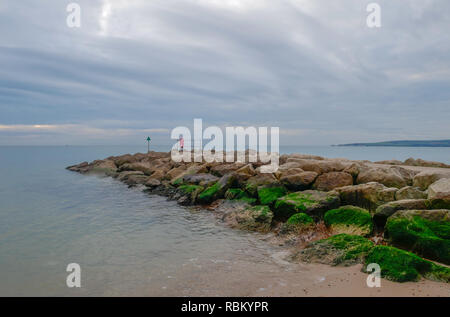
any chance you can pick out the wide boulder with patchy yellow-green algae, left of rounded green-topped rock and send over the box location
[274,190,340,219]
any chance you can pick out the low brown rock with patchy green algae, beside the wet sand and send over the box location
[298,233,374,266]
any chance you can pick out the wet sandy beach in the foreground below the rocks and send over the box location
[139,239,450,297]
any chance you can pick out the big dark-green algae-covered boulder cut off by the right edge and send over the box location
[385,209,450,264]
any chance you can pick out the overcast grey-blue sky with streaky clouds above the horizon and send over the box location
[0,0,450,145]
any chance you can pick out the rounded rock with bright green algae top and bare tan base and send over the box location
[323,206,373,236]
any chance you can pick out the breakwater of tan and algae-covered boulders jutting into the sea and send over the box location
[67,151,450,296]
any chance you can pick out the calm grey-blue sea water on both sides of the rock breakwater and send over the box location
[0,146,450,296]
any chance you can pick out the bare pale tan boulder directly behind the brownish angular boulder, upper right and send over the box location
[356,166,412,188]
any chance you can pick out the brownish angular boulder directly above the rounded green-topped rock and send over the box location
[335,182,398,211]
